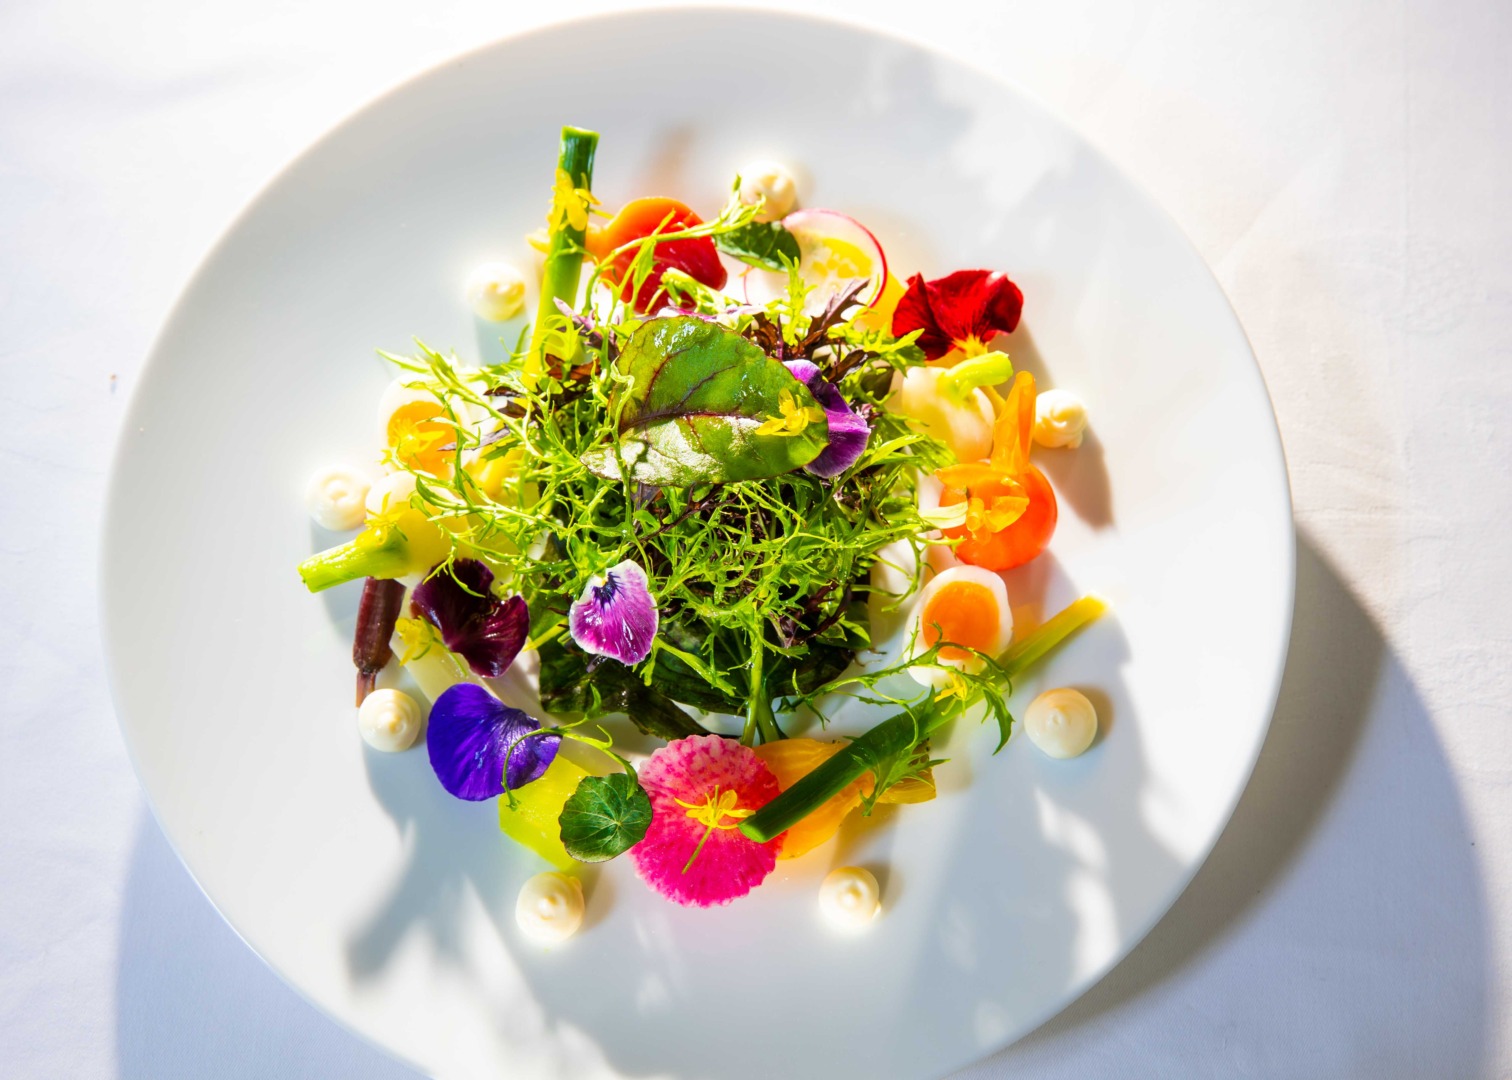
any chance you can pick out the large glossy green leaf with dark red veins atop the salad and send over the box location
[584,316,830,487]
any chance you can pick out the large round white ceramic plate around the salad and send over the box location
[104,12,1293,1077]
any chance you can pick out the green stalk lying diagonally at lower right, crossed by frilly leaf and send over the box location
[741,596,1107,844]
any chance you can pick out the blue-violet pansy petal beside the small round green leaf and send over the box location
[425,682,562,802]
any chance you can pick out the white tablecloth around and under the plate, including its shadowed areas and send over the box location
[0,0,1512,1080]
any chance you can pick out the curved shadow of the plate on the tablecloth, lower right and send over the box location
[985,534,1494,1080]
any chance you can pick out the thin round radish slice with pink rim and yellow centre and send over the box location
[744,210,888,315]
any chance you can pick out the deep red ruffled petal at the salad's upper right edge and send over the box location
[892,271,1024,360]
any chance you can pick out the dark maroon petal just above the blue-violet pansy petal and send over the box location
[410,558,531,679]
